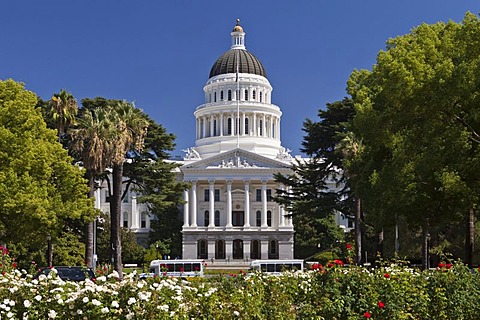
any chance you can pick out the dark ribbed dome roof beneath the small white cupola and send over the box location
[209,49,267,78]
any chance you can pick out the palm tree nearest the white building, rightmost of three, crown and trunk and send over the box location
[109,101,148,277]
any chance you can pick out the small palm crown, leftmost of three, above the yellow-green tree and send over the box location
[49,89,78,141]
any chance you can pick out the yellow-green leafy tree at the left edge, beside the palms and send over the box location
[0,80,94,262]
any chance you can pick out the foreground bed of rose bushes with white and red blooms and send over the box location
[0,254,480,320]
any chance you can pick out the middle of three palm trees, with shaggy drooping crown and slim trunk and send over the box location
[71,108,114,267]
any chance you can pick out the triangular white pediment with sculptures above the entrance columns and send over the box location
[181,149,290,170]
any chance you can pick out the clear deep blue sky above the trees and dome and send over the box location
[0,0,480,155]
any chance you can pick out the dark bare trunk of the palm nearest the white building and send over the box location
[110,163,123,278]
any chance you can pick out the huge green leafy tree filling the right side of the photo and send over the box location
[348,13,480,267]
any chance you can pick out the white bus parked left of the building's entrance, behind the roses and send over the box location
[149,259,205,277]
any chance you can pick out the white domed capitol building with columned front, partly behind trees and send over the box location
[97,20,347,261]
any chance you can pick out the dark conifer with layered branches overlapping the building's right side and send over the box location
[275,99,354,257]
